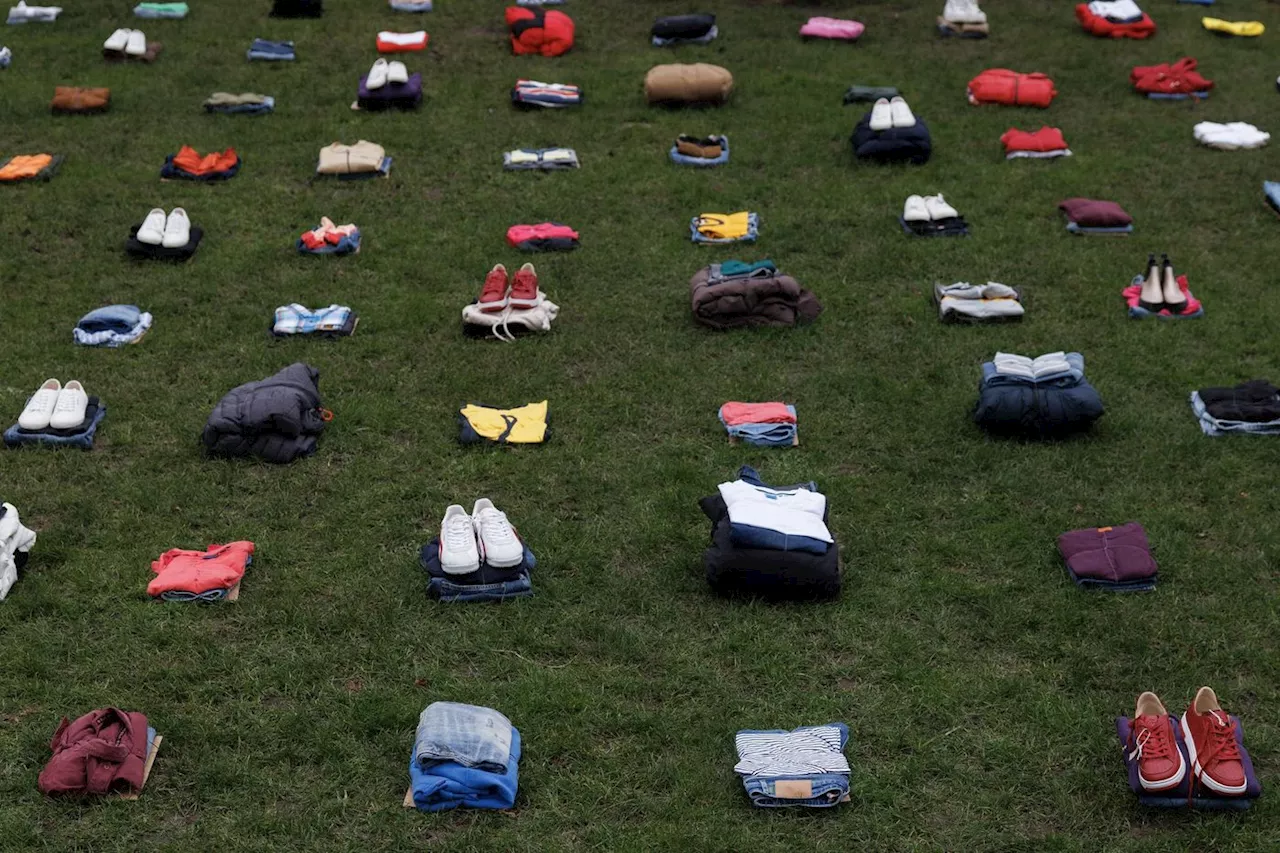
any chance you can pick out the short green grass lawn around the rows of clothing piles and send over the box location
[0,0,1280,852]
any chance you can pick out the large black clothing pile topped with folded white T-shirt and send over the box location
[698,465,840,601]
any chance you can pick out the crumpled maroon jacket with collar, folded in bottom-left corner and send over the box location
[36,708,147,795]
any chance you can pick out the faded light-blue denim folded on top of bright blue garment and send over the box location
[404,702,521,812]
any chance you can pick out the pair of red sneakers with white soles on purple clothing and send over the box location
[1132,686,1248,797]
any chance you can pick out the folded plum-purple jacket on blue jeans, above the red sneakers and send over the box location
[1057,521,1158,592]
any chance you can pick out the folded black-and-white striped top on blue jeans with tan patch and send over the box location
[733,722,850,808]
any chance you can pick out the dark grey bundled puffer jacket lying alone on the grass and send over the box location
[204,362,325,464]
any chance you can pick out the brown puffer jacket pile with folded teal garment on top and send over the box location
[689,260,822,329]
